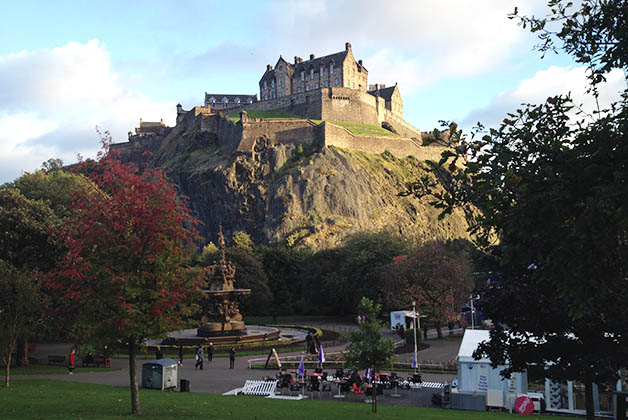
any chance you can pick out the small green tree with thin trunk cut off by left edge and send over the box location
[0,260,42,387]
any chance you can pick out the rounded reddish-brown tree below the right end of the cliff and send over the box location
[384,241,472,338]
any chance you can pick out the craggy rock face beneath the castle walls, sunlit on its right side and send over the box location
[113,127,468,249]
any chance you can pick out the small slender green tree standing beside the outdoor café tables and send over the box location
[347,297,393,413]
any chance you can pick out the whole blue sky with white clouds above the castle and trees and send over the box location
[0,0,625,184]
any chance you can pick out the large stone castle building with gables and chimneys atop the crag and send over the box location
[259,42,368,101]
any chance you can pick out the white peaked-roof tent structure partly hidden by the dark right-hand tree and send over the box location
[456,329,528,409]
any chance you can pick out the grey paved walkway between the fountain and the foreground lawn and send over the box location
[14,322,459,406]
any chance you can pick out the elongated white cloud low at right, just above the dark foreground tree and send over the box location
[462,66,626,128]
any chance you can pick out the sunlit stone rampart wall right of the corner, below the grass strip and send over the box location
[322,122,445,161]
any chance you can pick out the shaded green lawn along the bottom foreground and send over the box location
[0,379,567,420]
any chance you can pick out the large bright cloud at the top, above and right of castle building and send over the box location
[260,0,544,93]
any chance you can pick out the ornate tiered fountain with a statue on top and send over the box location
[196,228,251,337]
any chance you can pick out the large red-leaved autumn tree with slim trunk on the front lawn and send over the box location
[43,150,201,413]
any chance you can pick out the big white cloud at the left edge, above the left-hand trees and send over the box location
[0,40,176,182]
